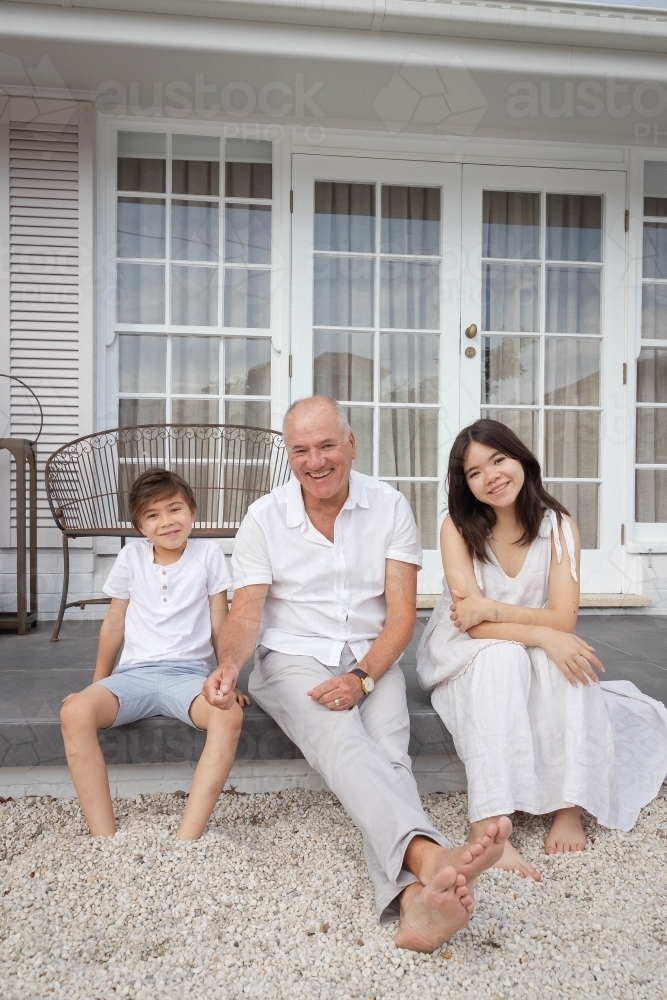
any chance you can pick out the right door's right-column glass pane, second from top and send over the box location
[546,267,602,333]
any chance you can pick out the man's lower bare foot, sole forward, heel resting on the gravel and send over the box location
[394,865,474,952]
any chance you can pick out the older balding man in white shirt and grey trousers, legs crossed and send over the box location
[204,396,511,951]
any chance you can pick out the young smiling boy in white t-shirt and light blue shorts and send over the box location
[60,469,250,840]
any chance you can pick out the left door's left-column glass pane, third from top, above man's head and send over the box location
[313,330,374,402]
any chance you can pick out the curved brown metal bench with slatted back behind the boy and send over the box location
[44,424,290,642]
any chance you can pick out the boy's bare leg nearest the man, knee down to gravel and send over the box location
[178,695,243,840]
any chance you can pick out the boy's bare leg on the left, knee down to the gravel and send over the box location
[60,684,118,837]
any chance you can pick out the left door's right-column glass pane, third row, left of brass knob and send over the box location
[380,333,440,403]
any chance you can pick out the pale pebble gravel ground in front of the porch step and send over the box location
[0,786,667,1000]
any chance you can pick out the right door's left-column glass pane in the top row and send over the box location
[482,191,540,260]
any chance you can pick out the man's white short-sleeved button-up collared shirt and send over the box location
[232,472,422,666]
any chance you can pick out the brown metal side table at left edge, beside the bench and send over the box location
[0,438,37,635]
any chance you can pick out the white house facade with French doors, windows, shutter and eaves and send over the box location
[0,0,667,617]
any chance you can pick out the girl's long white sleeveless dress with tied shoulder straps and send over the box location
[417,510,667,830]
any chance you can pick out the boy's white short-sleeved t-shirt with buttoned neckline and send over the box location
[103,538,232,666]
